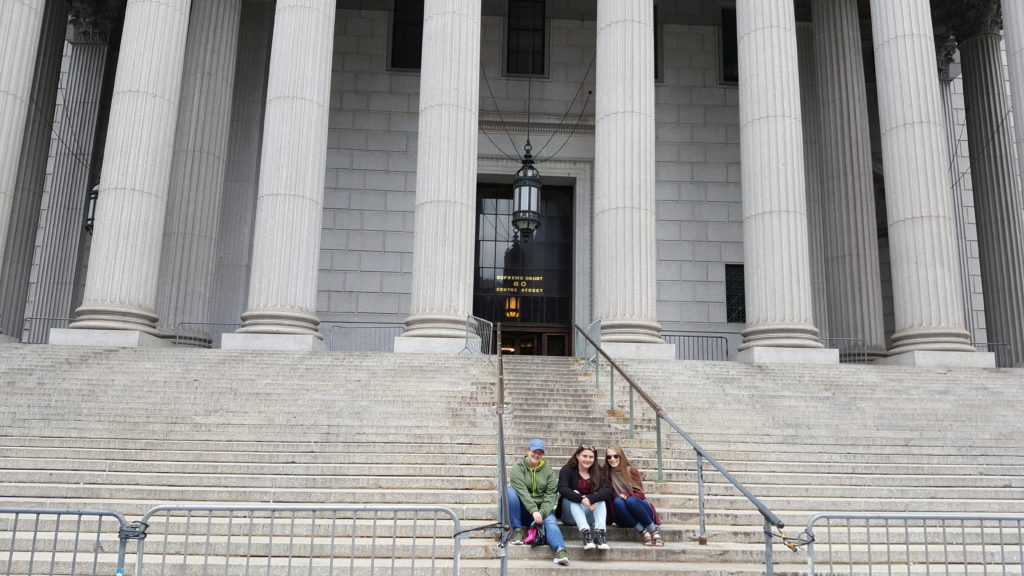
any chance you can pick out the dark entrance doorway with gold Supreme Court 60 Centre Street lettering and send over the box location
[473,183,573,356]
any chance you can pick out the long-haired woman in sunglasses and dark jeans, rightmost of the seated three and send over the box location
[604,445,665,546]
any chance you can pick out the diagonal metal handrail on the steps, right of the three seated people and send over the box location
[573,324,785,576]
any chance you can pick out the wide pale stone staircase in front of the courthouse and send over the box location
[0,344,1024,575]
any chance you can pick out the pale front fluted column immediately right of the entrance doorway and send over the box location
[594,0,671,357]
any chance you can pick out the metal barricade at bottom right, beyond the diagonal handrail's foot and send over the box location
[804,513,1024,576]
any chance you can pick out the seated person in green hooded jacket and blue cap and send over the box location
[509,438,569,566]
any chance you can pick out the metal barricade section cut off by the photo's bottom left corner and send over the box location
[0,508,133,576]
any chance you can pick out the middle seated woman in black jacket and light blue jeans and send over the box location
[558,444,611,550]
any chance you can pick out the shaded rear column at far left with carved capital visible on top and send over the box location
[29,13,110,341]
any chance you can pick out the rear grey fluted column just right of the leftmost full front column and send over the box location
[157,0,242,345]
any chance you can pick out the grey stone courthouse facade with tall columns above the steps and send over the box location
[0,0,1024,366]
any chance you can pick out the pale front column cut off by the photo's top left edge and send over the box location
[0,0,46,313]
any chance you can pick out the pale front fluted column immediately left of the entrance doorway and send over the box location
[394,0,480,354]
